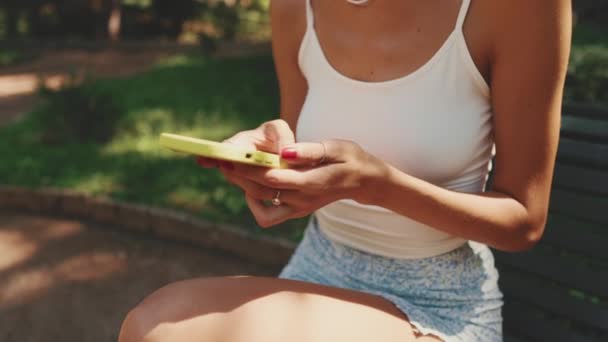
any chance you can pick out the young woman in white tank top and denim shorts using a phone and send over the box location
[120,0,571,342]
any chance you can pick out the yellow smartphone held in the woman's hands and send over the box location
[160,133,287,169]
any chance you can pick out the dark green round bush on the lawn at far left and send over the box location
[35,83,123,144]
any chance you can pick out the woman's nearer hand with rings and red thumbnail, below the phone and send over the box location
[220,140,388,227]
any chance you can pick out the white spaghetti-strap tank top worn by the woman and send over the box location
[296,0,494,259]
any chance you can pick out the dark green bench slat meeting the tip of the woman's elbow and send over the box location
[540,213,608,260]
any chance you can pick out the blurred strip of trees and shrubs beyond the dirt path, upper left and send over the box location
[0,0,269,42]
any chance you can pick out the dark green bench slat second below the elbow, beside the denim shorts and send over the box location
[500,272,608,334]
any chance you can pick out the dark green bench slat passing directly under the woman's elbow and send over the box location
[494,248,608,298]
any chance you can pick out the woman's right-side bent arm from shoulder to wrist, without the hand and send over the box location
[364,0,572,251]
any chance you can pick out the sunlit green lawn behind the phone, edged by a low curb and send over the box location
[0,56,302,239]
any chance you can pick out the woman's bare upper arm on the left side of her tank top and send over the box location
[270,0,308,132]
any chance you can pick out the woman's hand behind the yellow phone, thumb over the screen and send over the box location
[197,119,295,170]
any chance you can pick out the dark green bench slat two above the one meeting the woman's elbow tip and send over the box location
[553,163,608,195]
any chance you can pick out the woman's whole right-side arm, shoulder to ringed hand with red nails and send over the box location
[217,0,571,251]
